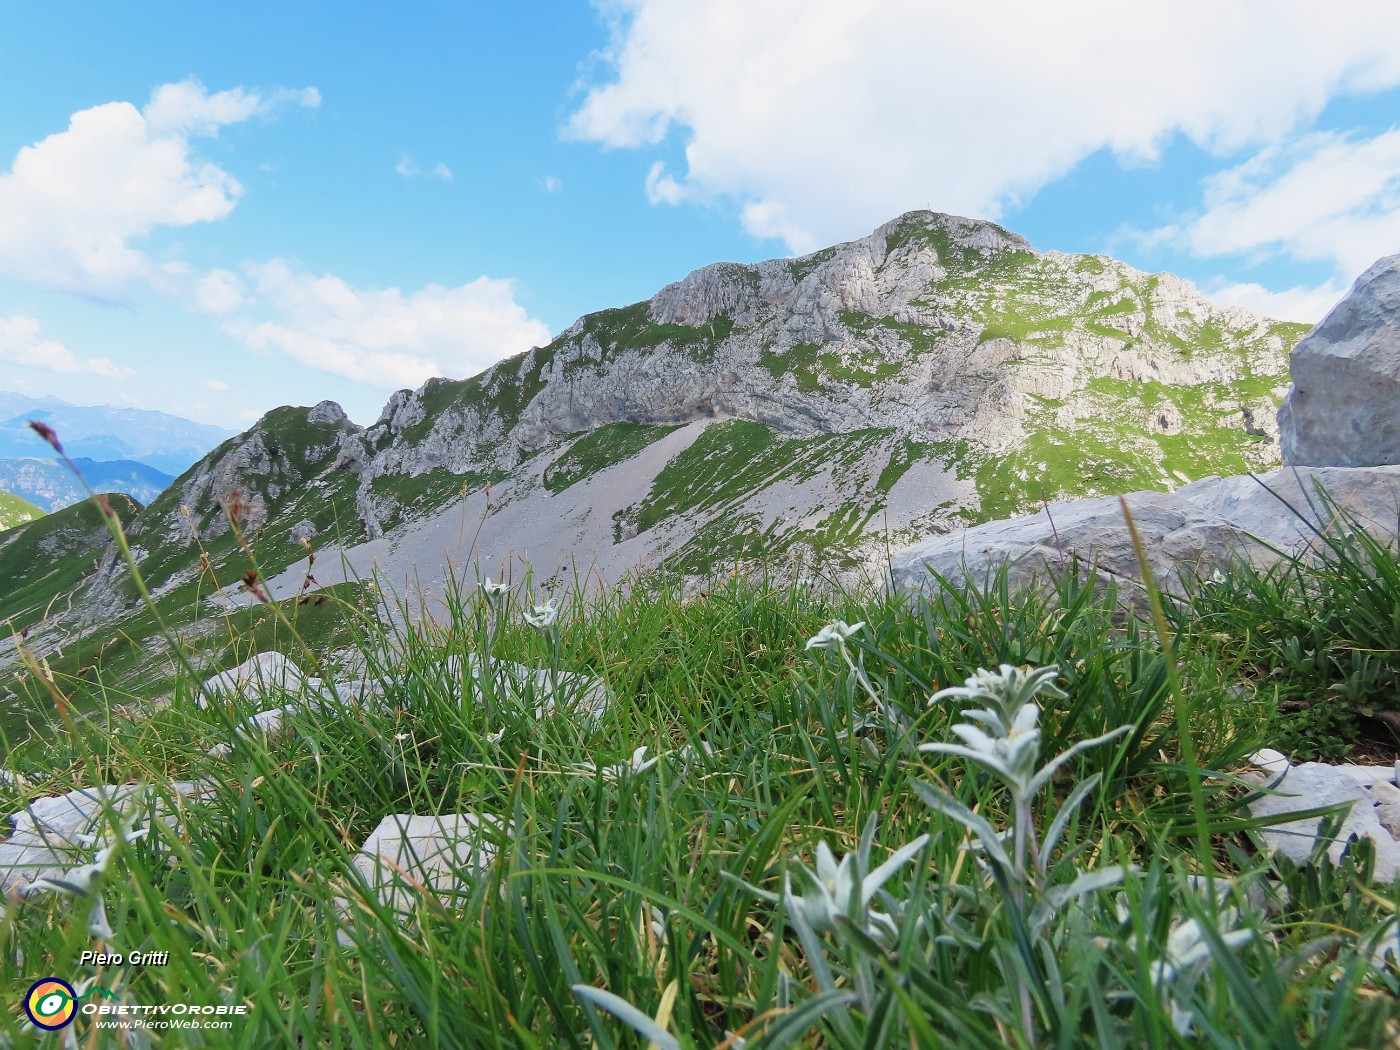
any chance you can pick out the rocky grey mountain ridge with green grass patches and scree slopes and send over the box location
[0,211,1305,700]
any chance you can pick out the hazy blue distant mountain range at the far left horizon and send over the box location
[0,391,234,477]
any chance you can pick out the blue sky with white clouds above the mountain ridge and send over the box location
[0,0,1400,427]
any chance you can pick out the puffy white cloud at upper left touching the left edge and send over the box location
[0,80,319,300]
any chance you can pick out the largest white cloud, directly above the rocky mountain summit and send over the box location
[567,0,1400,249]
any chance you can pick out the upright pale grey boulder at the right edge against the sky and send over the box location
[1278,255,1400,466]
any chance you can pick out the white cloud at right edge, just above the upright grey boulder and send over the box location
[1149,130,1400,277]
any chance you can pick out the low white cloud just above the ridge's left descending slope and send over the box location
[225,259,549,389]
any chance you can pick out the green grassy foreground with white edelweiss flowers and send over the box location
[0,518,1400,1050]
